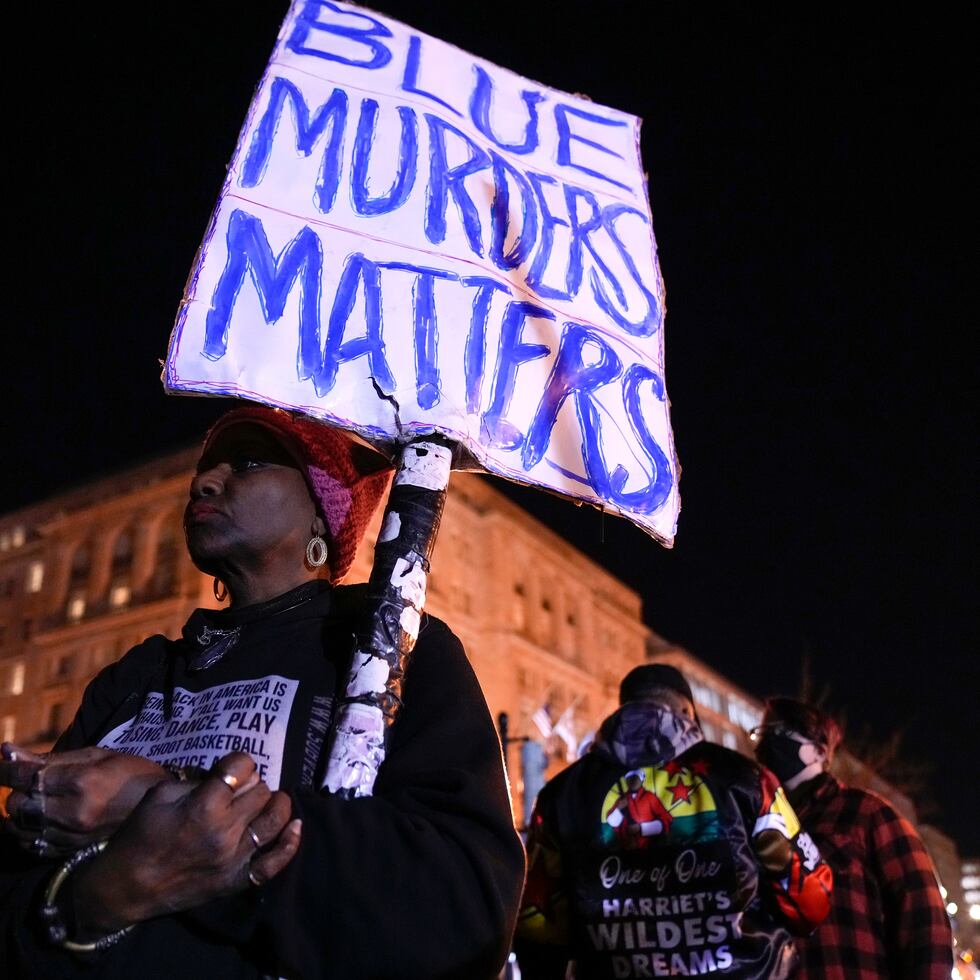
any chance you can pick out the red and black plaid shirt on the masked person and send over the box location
[790,775,953,980]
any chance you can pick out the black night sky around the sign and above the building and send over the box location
[0,0,980,855]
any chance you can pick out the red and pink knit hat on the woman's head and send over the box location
[201,405,392,582]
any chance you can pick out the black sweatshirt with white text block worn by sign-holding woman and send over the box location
[0,588,524,980]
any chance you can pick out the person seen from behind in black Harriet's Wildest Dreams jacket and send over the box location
[515,664,832,980]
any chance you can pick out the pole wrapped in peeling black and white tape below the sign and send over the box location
[323,436,453,798]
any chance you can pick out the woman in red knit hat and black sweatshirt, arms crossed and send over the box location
[0,407,524,980]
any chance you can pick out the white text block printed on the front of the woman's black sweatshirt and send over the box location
[99,674,299,789]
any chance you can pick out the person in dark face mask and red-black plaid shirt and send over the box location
[753,698,953,980]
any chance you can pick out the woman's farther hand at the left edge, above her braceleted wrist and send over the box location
[0,743,173,857]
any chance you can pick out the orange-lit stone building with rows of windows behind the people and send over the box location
[0,447,964,896]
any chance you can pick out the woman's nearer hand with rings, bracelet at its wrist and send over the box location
[73,752,300,936]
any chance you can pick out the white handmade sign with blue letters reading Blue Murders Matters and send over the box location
[164,0,679,545]
